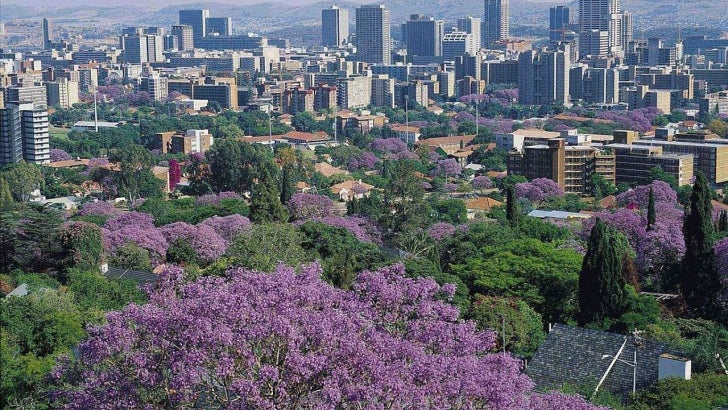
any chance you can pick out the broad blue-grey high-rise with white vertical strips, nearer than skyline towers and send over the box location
[518,45,571,105]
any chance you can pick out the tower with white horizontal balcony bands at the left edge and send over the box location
[0,101,50,166]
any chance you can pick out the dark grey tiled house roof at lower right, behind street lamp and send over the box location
[526,324,670,397]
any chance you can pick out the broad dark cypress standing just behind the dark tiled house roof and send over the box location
[577,219,627,326]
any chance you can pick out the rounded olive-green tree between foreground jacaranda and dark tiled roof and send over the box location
[467,295,546,357]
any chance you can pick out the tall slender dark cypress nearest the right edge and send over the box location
[680,172,720,317]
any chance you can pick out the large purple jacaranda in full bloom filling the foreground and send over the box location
[49,265,594,410]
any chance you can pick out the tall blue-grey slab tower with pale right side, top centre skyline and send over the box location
[356,5,392,65]
